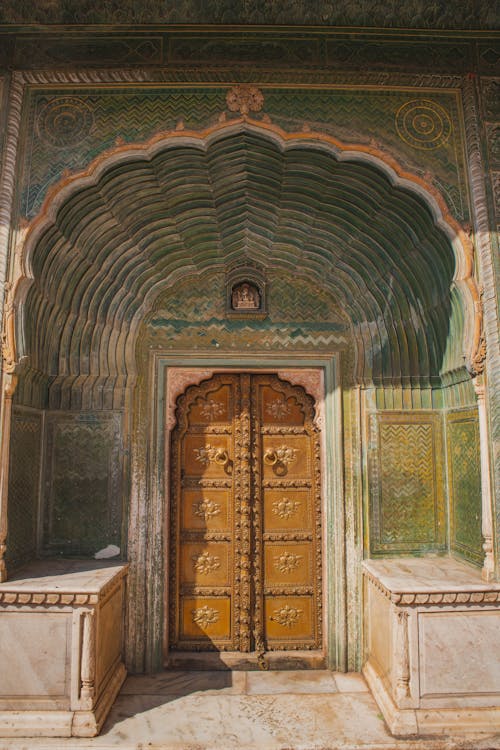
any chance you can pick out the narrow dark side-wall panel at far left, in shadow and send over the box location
[7,409,42,568]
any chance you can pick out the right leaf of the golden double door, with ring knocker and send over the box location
[252,375,321,651]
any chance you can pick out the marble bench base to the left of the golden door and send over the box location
[0,560,127,737]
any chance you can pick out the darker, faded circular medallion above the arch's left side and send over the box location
[37,96,94,148]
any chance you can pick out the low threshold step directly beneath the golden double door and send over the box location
[165,651,326,671]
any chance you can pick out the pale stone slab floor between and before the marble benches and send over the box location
[0,671,500,750]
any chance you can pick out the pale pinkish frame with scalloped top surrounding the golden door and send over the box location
[148,352,347,669]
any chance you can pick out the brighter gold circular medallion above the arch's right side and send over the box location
[396,99,452,150]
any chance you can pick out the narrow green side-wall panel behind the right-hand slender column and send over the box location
[446,409,483,565]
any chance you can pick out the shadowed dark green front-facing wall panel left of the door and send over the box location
[44,412,123,556]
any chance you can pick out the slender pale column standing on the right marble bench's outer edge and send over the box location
[473,376,495,581]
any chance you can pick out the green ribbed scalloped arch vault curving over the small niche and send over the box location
[16,122,473,408]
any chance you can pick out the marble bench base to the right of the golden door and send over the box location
[363,558,500,736]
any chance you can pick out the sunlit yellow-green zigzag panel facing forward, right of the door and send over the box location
[370,411,446,555]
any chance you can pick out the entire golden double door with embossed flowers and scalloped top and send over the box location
[169,373,322,666]
